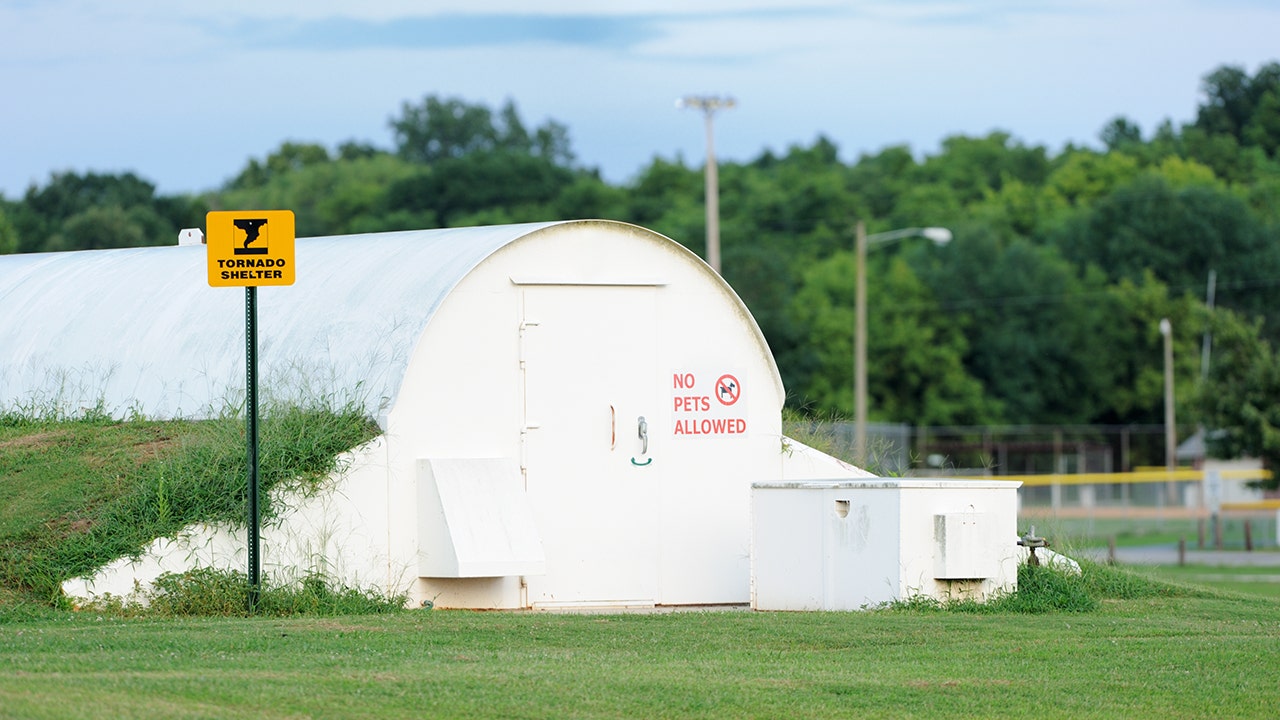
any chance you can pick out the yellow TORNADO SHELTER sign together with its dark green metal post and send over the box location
[205,210,294,612]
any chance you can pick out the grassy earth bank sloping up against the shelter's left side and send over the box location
[0,406,376,605]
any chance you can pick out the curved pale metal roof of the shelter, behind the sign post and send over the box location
[0,223,562,416]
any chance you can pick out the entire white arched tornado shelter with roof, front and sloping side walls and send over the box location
[0,220,864,607]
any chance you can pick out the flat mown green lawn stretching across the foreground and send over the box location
[0,597,1280,719]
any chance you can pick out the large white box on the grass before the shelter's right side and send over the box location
[751,478,1021,610]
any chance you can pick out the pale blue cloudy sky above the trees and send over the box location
[0,0,1280,200]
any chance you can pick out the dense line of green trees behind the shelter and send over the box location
[0,63,1280,476]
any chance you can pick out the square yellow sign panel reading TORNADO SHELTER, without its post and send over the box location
[205,210,294,287]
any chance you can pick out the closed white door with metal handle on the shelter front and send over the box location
[521,284,667,606]
